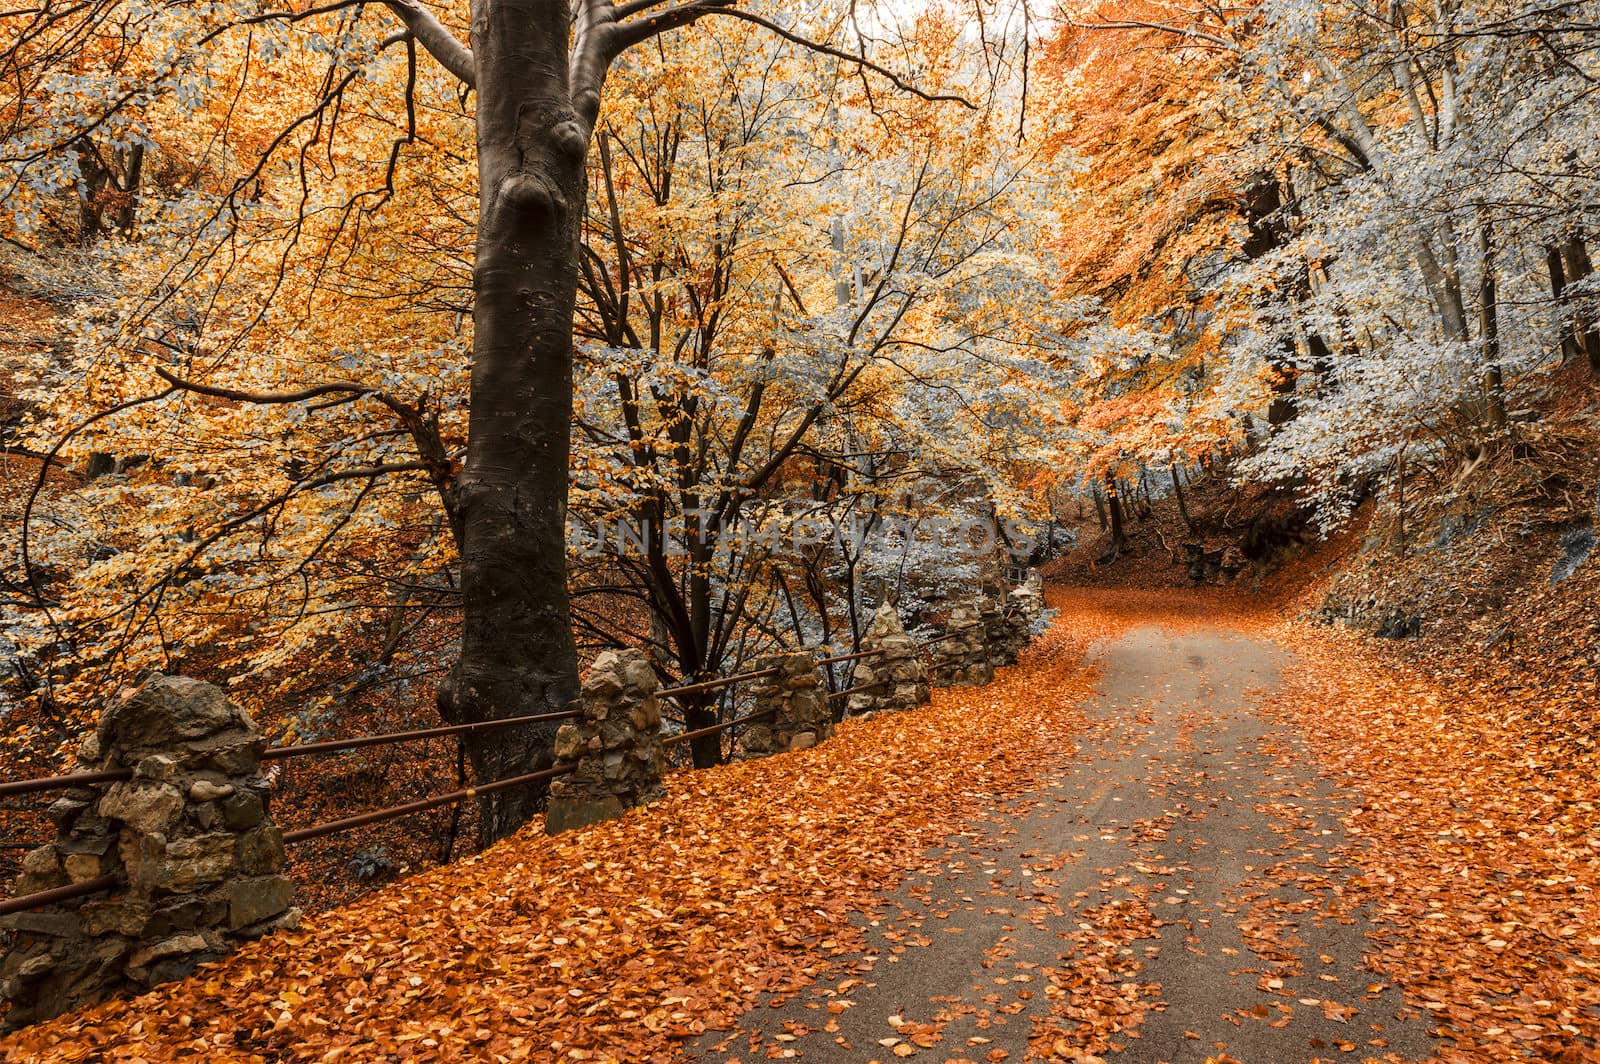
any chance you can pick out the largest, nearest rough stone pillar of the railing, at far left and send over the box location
[0,677,299,1027]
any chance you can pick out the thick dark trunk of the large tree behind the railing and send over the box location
[438,0,587,842]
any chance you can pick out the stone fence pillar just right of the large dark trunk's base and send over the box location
[544,650,666,835]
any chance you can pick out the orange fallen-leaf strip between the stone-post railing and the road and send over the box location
[0,624,1088,1062]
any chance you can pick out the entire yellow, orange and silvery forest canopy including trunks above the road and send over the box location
[0,0,1600,832]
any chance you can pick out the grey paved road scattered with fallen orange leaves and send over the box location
[690,627,1432,1064]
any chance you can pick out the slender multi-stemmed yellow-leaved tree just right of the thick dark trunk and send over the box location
[574,16,1075,763]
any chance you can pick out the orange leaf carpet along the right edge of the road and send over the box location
[1267,626,1600,1062]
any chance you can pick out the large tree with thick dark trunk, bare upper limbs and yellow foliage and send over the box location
[3,0,1049,835]
